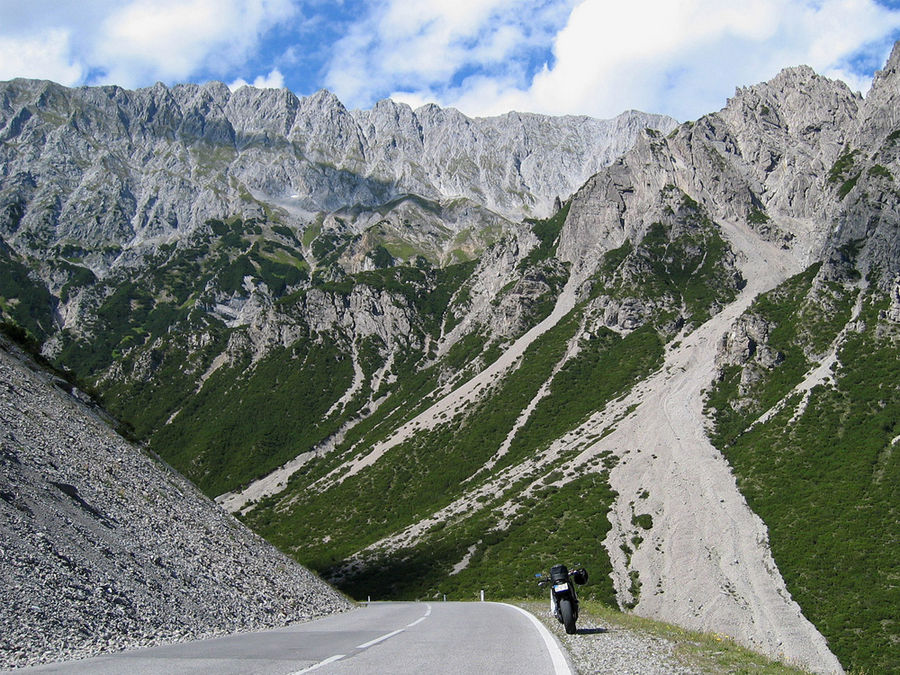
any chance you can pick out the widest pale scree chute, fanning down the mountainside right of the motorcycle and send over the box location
[575,223,842,673]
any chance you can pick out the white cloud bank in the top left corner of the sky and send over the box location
[0,0,297,87]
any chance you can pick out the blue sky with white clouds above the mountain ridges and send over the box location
[0,0,900,121]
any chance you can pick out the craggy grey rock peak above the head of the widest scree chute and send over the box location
[559,42,900,289]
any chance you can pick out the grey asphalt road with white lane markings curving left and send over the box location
[16,602,571,675]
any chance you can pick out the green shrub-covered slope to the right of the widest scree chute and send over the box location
[714,288,900,672]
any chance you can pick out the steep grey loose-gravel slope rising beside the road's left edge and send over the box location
[0,341,350,668]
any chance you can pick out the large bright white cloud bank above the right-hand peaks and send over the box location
[327,0,900,119]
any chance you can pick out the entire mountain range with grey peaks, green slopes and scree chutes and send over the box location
[0,46,900,672]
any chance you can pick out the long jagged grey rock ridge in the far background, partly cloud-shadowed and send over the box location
[0,80,675,270]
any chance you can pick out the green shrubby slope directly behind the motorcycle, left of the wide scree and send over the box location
[320,472,615,602]
